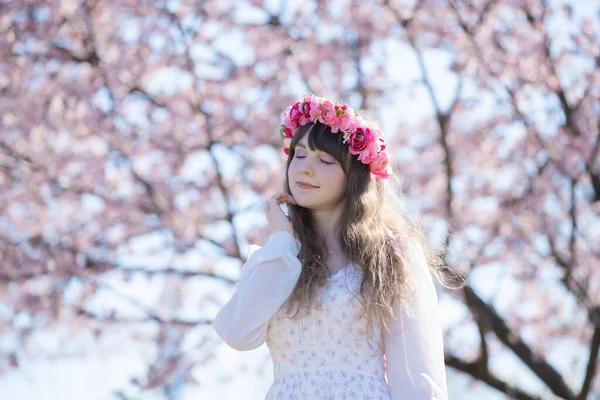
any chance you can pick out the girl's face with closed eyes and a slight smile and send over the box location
[288,134,346,210]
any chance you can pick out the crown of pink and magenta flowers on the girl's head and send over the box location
[280,95,392,179]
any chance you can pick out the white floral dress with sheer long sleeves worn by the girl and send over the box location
[215,231,447,400]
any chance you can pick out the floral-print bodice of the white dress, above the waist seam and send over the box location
[266,264,386,398]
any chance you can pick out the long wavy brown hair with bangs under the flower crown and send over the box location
[284,122,460,353]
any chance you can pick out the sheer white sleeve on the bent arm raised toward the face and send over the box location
[214,230,302,351]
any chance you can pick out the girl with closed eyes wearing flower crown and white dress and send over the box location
[215,95,447,400]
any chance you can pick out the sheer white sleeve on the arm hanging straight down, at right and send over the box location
[385,244,448,400]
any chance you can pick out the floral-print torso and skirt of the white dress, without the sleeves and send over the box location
[265,264,390,400]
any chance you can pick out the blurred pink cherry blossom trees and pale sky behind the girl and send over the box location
[0,0,600,400]
